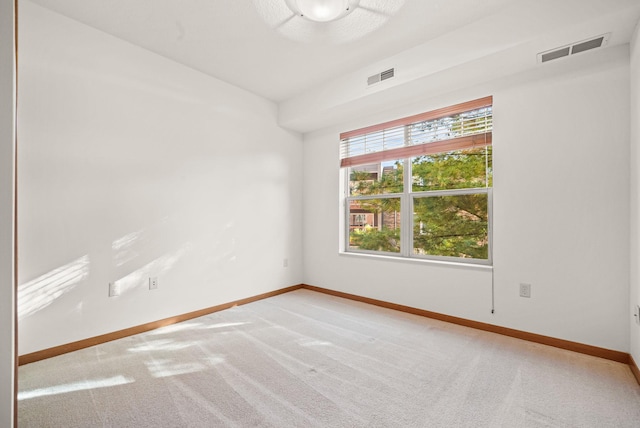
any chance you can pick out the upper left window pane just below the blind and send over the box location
[349,160,403,196]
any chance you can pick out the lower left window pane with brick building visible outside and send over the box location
[349,198,400,253]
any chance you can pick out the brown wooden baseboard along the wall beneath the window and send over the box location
[302,284,640,364]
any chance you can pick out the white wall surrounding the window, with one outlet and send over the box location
[303,45,629,352]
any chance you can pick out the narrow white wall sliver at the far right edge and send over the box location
[629,23,640,364]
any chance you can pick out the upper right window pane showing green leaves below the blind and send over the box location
[411,146,492,192]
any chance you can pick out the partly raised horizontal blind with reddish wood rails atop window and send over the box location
[340,96,493,167]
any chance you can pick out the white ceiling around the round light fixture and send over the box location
[21,0,640,131]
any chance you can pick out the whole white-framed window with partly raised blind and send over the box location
[340,97,493,264]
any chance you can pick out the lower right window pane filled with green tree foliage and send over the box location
[413,193,489,259]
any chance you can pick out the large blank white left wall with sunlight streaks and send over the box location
[18,2,302,354]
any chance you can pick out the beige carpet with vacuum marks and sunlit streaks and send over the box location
[19,290,640,428]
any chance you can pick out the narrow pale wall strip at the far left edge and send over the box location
[0,0,15,427]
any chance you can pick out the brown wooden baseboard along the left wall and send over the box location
[18,285,302,365]
